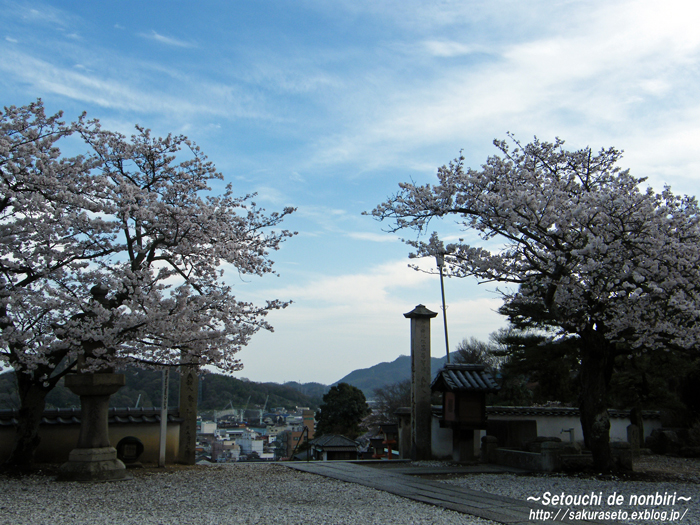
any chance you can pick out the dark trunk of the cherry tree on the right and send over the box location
[579,329,614,472]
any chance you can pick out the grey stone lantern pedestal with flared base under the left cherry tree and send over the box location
[58,373,130,481]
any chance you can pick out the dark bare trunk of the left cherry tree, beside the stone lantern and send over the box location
[5,372,50,471]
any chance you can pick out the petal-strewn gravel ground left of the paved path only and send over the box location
[0,463,493,525]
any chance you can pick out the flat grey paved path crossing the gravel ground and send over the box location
[285,461,600,525]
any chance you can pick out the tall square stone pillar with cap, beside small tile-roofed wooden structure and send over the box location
[403,304,437,460]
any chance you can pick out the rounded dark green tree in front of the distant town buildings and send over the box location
[316,383,370,439]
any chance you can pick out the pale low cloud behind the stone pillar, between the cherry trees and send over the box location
[234,260,505,384]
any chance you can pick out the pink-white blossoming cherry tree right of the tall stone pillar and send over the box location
[372,137,700,471]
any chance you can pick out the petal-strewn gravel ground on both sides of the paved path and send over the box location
[0,457,700,525]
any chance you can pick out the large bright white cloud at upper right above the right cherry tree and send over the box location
[313,2,700,184]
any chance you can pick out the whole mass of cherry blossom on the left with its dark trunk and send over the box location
[0,101,293,465]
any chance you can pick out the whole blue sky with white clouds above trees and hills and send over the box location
[0,0,700,383]
